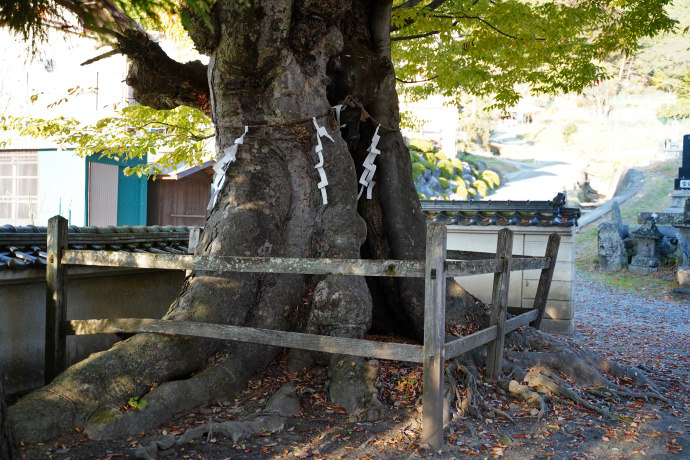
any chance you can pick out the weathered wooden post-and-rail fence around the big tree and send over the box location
[45,216,560,448]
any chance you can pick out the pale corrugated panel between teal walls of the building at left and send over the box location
[88,161,120,226]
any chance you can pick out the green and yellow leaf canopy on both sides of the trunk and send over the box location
[0,0,678,174]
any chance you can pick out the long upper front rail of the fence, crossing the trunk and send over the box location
[62,249,425,278]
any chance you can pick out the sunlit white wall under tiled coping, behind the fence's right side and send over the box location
[448,225,575,335]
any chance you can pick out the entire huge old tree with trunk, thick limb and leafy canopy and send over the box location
[0,0,674,446]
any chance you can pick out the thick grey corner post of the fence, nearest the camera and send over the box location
[422,223,447,449]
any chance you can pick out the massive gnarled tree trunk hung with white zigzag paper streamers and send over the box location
[5,0,481,441]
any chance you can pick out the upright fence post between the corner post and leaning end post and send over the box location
[486,228,513,379]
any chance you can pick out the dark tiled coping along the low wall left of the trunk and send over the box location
[0,225,191,270]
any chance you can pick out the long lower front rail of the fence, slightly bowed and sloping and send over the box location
[62,318,422,363]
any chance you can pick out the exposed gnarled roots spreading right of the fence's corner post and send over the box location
[446,328,670,428]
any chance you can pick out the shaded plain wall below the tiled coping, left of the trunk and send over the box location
[0,267,184,395]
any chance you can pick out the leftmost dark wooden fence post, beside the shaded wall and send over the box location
[44,216,67,384]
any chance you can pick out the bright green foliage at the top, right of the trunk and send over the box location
[392,0,676,107]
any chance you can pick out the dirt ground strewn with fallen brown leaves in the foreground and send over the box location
[12,328,690,460]
